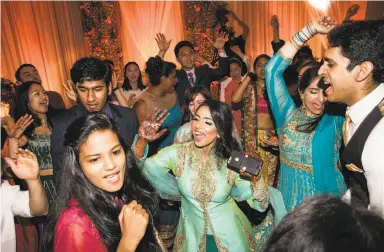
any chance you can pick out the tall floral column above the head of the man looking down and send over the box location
[79,1,123,75]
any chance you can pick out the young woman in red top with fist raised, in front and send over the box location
[44,113,165,252]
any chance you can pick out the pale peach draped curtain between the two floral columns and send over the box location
[119,1,184,70]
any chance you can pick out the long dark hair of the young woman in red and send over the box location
[44,113,158,251]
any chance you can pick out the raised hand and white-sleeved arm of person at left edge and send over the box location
[0,149,48,252]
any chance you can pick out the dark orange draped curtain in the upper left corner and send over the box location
[1,1,87,105]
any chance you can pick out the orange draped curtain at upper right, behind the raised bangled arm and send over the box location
[228,1,367,59]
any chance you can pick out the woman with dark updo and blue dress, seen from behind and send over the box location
[134,56,183,249]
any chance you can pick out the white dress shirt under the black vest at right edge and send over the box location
[344,83,384,218]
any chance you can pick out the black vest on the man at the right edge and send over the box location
[341,100,384,207]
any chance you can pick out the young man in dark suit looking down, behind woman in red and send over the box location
[51,57,145,181]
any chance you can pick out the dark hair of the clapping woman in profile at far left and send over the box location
[13,81,58,139]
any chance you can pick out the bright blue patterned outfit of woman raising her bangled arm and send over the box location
[265,53,346,211]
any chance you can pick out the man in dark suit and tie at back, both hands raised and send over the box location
[157,33,229,106]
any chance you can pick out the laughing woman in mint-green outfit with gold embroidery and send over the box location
[136,100,285,252]
